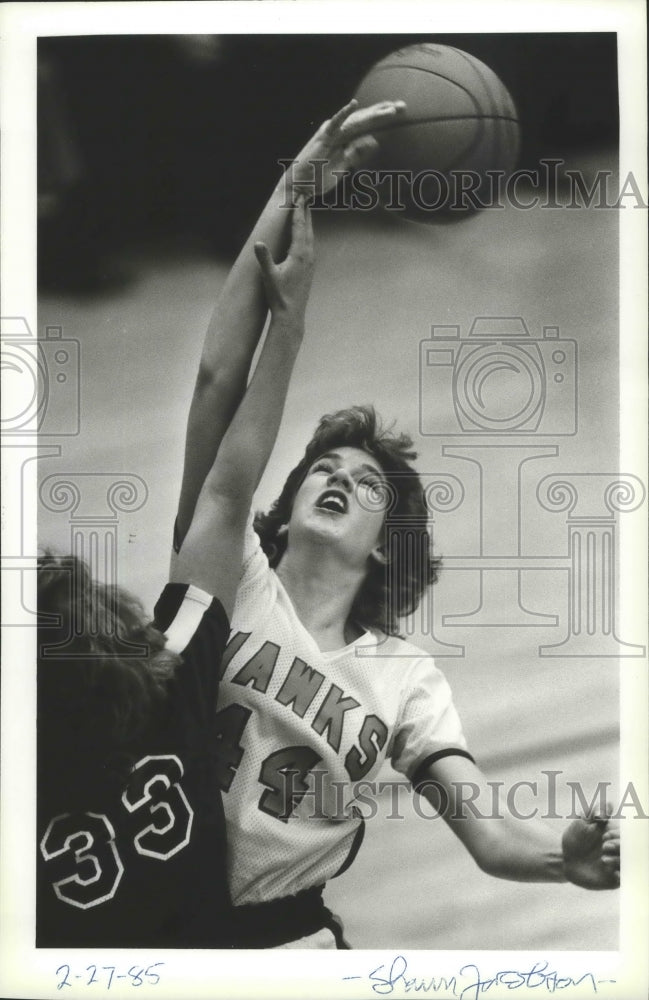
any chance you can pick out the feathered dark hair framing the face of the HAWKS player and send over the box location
[254,406,440,635]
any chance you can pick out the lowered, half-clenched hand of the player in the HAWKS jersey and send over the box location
[561,813,620,889]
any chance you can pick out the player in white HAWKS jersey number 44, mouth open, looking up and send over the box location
[177,103,619,947]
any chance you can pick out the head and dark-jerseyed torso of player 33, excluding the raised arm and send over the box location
[37,556,229,947]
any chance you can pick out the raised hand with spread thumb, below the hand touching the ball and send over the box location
[255,194,314,327]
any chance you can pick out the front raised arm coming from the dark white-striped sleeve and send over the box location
[170,196,313,614]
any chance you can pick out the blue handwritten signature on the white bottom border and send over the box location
[344,955,615,1000]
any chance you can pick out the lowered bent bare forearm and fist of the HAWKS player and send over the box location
[422,756,619,889]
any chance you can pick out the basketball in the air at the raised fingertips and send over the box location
[355,43,520,222]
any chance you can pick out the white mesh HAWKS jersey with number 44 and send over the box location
[217,524,465,905]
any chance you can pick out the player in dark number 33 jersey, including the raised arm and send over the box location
[37,197,313,948]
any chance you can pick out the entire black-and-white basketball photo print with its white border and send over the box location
[2,4,649,998]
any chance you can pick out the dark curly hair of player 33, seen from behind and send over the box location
[37,552,180,769]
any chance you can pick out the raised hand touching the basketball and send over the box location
[289,100,405,197]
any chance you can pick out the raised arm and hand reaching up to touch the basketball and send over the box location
[177,101,403,541]
